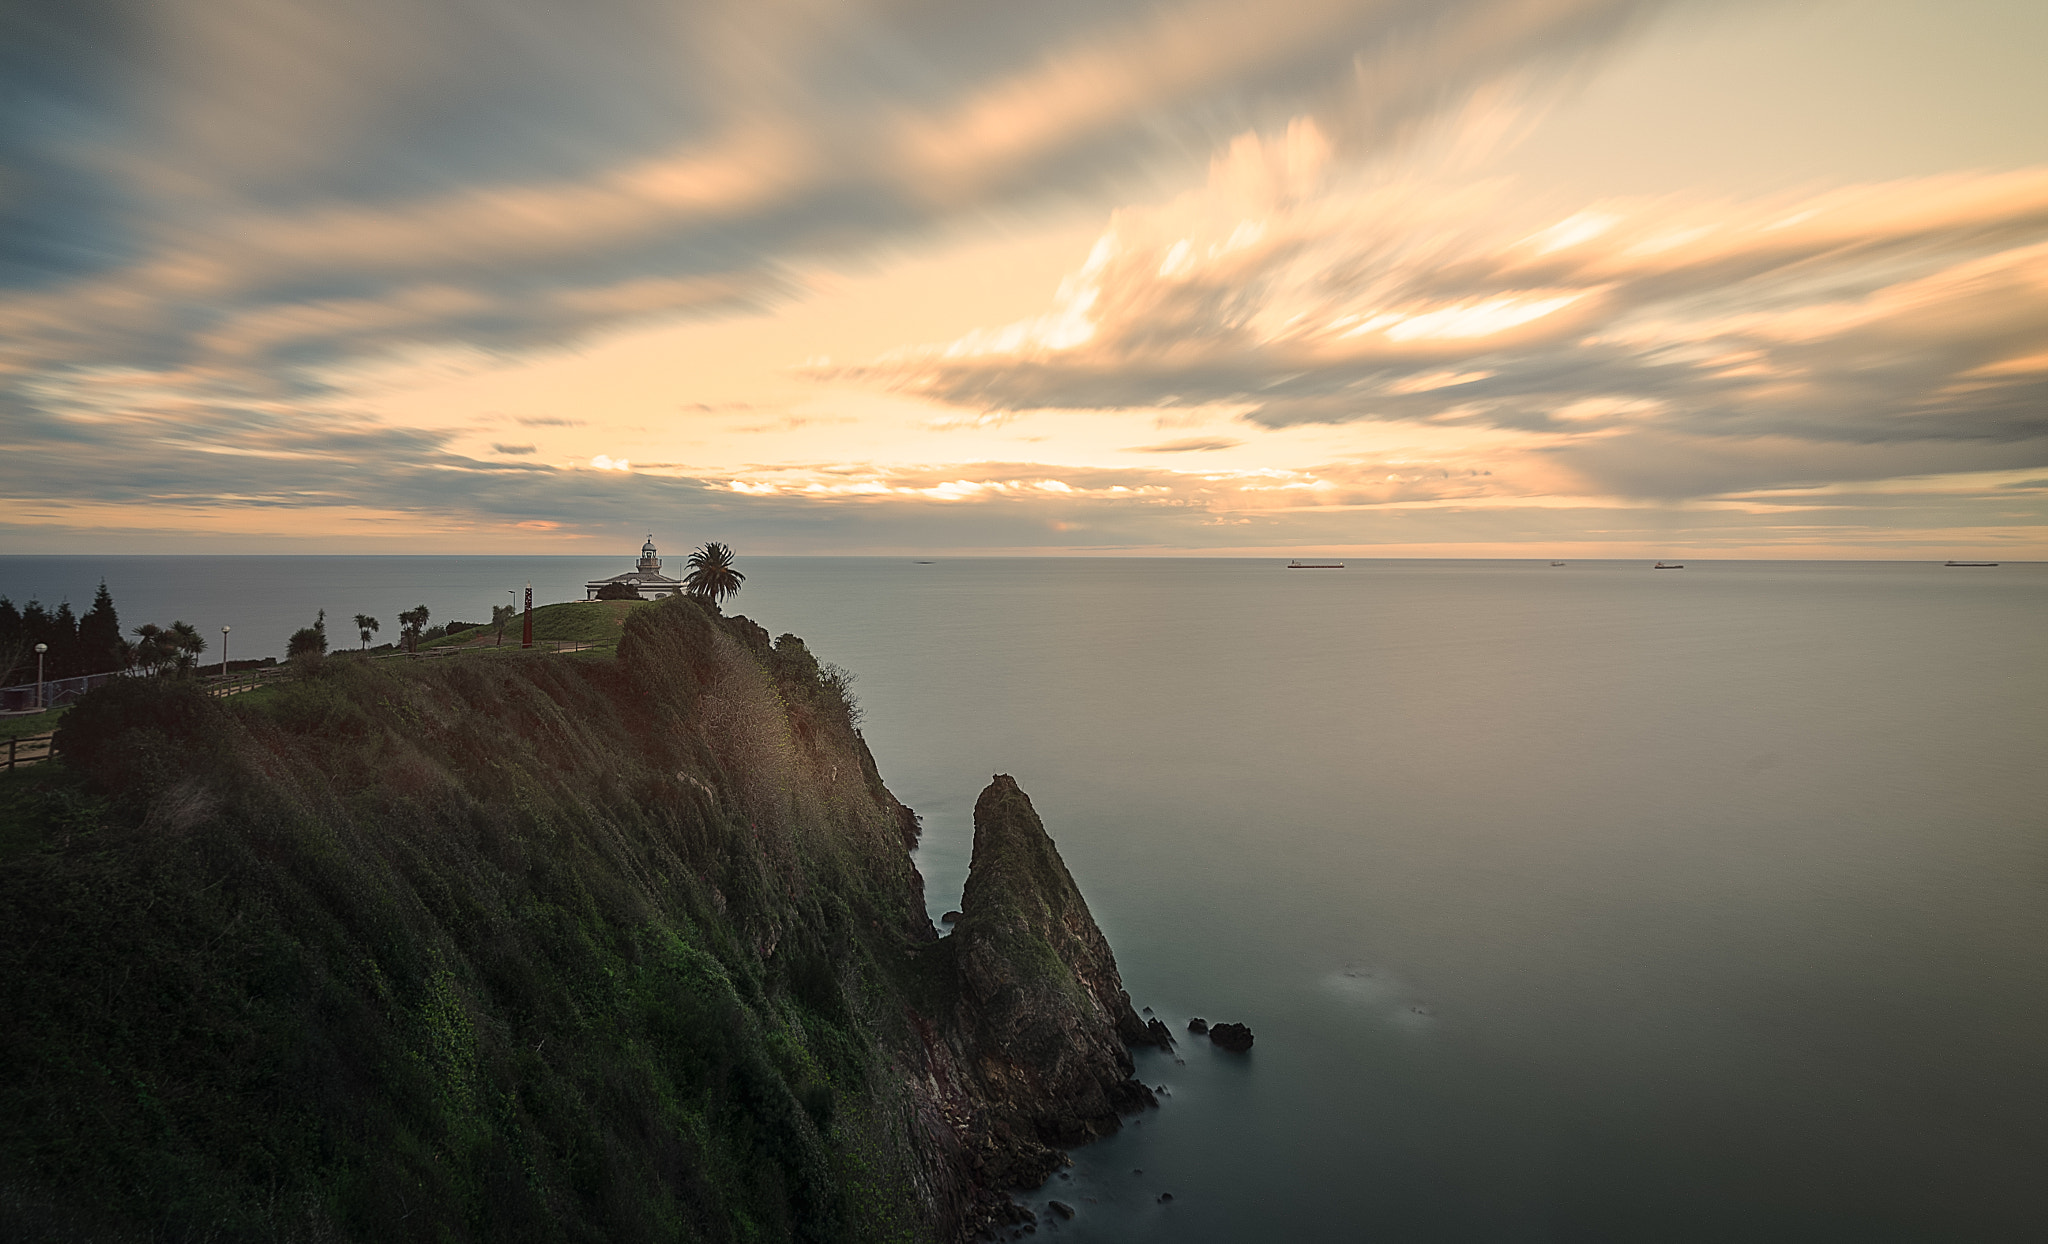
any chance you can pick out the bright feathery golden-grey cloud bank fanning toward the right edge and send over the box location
[836,121,2048,496]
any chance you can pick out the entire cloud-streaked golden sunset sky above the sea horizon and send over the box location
[0,0,2048,559]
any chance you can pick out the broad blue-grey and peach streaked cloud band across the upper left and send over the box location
[0,0,1657,397]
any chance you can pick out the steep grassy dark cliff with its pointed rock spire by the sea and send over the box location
[0,600,1149,1244]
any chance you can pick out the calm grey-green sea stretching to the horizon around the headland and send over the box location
[0,557,2048,1242]
